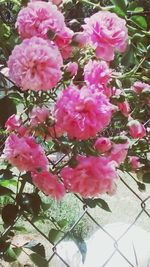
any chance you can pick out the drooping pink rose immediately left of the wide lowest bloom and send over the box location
[31,171,65,200]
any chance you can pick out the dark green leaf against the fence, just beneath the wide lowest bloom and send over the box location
[84,198,111,212]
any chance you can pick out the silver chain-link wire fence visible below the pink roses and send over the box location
[0,120,150,267]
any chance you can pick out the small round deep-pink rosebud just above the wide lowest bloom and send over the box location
[94,137,112,153]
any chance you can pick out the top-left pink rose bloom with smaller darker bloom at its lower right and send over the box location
[16,1,73,59]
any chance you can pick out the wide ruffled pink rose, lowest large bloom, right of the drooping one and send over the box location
[61,156,117,198]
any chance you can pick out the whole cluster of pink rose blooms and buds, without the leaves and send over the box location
[4,0,150,203]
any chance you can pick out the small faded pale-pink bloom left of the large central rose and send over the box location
[29,106,50,126]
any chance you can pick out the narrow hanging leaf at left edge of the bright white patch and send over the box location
[71,232,87,263]
